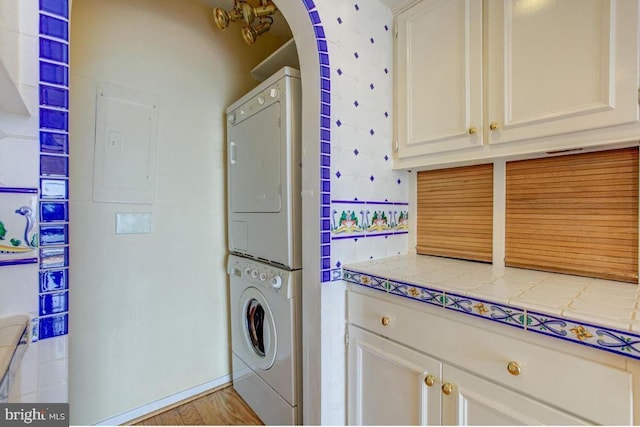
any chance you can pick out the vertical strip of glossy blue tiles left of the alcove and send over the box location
[38,0,69,341]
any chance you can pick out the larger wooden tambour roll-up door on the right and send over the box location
[505,148,638,283]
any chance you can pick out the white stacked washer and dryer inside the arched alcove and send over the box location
[227,67,302,425]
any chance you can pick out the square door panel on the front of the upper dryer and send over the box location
[229,102,282,213]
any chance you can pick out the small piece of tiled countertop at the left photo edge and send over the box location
[0,314,29,402]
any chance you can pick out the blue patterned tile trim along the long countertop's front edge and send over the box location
[342,268,640,360]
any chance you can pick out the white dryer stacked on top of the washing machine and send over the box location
[227,67,302,270]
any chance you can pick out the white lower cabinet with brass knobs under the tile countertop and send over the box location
[347,289,634,425]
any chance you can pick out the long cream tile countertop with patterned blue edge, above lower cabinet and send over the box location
[342,254,640,359]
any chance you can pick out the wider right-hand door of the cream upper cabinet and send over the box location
[485,0,638,144]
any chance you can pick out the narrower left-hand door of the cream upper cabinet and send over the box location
[395,0,482,158]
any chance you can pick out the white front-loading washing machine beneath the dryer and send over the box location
[227,255,302,425]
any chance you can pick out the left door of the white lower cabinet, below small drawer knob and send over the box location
[347,326,441,425]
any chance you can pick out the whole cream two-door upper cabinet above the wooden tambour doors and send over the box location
[394,0,640,168]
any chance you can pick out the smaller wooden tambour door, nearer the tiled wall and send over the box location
[416,164,493,262]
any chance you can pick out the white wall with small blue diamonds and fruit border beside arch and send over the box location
[316,1,411,281]
